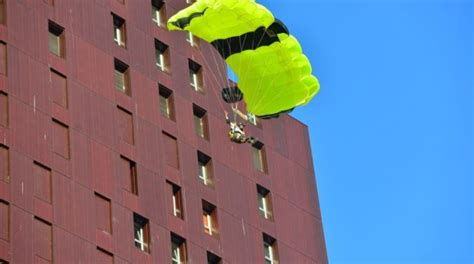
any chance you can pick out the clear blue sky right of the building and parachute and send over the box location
[258,0,474,264]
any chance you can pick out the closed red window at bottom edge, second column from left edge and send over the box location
[32,216,53,263]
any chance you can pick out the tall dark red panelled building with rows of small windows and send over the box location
[0,0,327,263]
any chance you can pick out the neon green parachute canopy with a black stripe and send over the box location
[168,0,319,118]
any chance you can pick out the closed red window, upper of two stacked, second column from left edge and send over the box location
[33,161,52,203]
